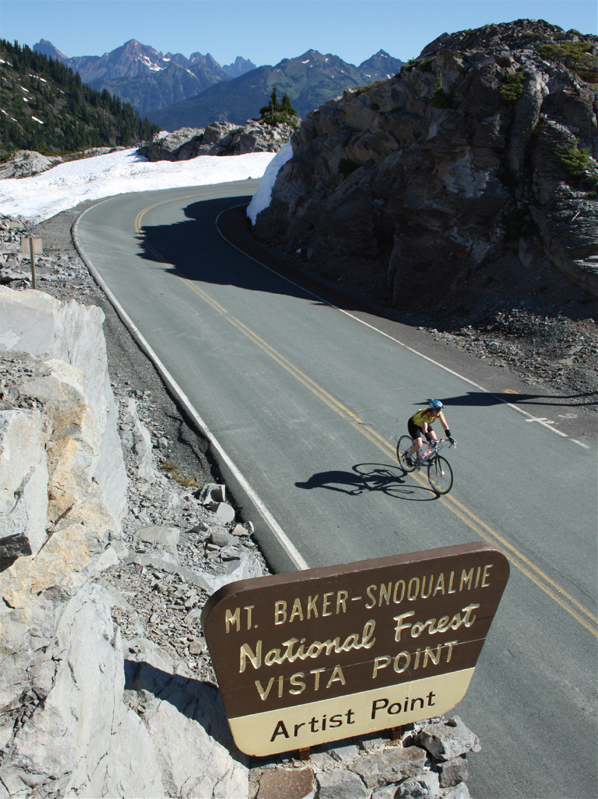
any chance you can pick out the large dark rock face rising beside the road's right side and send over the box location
[255,20,598,307]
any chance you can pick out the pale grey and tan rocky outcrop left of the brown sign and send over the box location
[0,289,252,799]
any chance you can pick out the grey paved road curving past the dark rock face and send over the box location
[78,181,597,799]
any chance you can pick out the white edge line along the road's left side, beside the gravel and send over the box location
[72,201,309,571]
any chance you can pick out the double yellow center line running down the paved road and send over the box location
[135,195,598,637]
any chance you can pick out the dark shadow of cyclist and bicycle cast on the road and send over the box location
[295,463,437,502]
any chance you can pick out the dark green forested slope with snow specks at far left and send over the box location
[0,39,159,155]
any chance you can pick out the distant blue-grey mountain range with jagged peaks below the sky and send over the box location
[33,39,403,130]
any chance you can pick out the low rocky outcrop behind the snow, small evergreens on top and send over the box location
[138,119,294,161]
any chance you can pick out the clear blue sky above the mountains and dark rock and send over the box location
[0,0,598,66]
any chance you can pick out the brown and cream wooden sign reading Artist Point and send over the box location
[202,544,509,756]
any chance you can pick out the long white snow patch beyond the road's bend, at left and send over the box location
[0,146,276,223]
